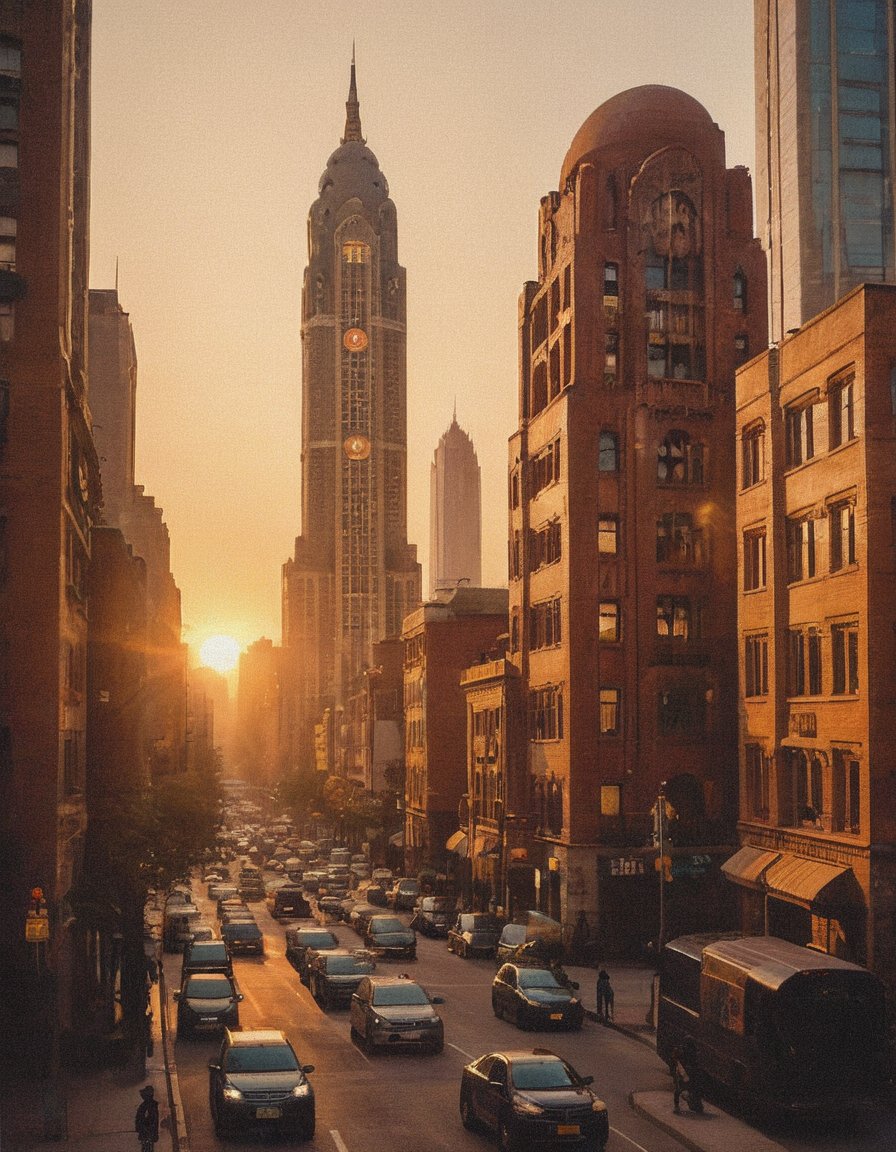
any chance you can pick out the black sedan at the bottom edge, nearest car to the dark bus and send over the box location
[461,1048,609,1152]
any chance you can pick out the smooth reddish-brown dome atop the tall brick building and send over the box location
[560,84,715,189]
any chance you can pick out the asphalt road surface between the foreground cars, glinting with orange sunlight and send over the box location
[166,897,682,1152]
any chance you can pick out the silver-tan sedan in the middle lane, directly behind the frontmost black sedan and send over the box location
[351,976,445,1053]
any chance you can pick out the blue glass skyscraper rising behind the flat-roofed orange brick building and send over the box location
[755,0,896,341]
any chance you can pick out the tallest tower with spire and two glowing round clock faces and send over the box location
[283,58,420,767]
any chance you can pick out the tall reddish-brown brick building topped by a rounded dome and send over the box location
[503,85,767,956]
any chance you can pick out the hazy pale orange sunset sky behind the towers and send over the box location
[91,0,753,645]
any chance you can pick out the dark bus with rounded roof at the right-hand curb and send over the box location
[656,934,891,1115]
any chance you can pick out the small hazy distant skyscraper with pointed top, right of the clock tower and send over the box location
[430,414,483,597]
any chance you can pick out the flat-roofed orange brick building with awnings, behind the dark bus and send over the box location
[724,285,896,984]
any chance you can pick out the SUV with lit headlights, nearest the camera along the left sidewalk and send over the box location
[208,1028,314,1140]
